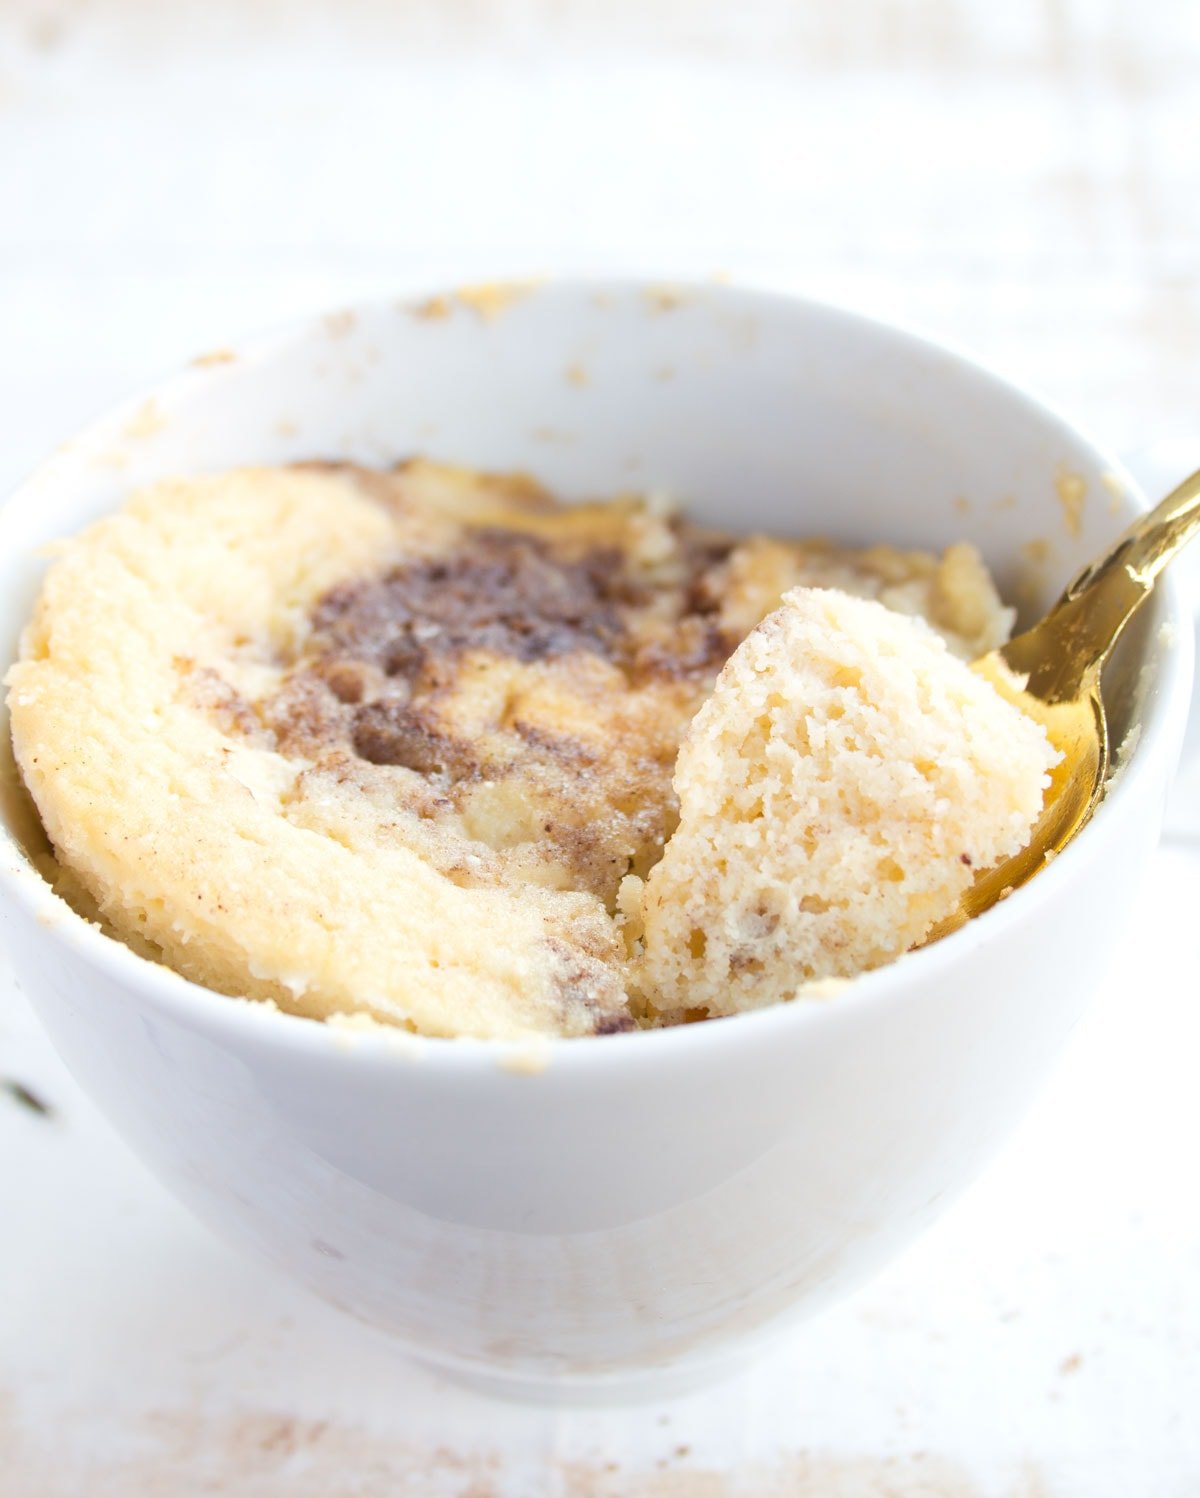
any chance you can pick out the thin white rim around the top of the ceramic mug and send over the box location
[0,276,1193,1077]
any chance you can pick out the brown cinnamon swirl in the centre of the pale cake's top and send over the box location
[258,494,737,908]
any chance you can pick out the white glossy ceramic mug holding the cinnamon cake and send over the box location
[0,283,1191,1393]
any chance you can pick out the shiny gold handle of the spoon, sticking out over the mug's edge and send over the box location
[1001,472,1200,703]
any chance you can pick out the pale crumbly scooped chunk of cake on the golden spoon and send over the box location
[622,589,1059,1023]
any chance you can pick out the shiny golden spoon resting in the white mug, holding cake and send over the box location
[926,473,1200,942]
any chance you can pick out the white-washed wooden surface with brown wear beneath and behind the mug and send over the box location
[0,0,1200,1498]
